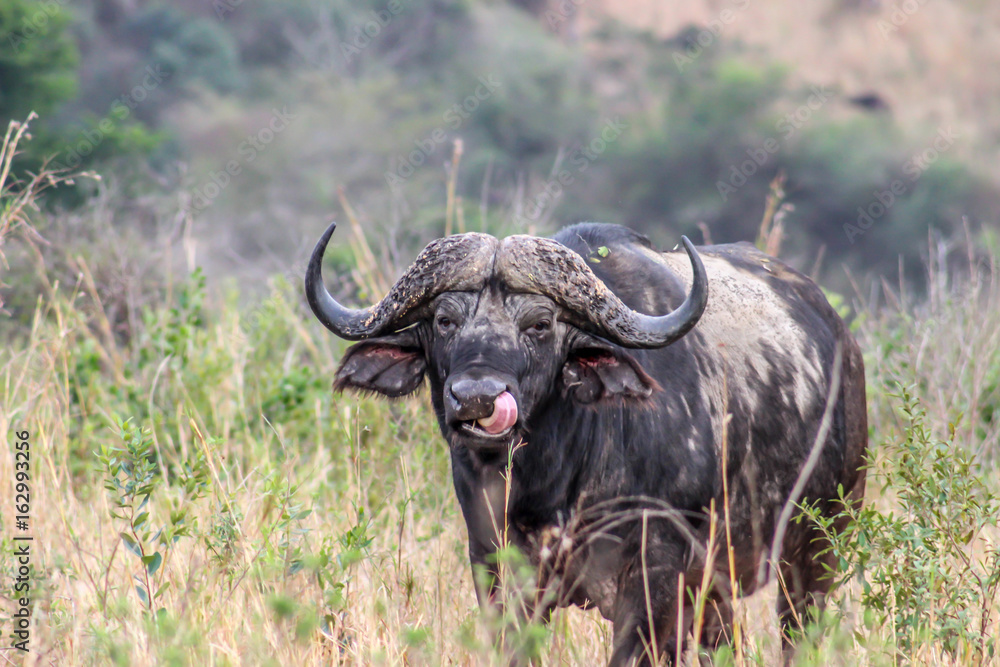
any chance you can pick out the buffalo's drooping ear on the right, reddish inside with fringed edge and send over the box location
[562,344,660,404]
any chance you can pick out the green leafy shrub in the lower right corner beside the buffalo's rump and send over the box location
[806,390,1000,663]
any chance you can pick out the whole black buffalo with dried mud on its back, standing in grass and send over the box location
[306,223,868,665]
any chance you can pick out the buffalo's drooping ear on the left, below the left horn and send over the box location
[333,332,427,398]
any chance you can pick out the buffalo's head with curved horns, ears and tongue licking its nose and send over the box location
[306,224,708,453]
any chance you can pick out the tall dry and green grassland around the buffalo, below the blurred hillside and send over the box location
[0,122,1000,665]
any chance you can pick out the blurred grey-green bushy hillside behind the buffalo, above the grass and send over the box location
[0,0,1000,290]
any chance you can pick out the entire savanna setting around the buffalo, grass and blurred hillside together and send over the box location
[0,0,1000,667]
